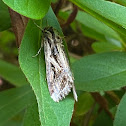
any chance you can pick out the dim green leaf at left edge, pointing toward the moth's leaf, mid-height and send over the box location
[0,60,28,87]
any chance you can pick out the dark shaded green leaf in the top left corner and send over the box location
[0,0,11,31]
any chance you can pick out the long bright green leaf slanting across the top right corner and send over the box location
[70,0,126,28]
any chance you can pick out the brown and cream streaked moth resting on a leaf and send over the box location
[34,23,77,102]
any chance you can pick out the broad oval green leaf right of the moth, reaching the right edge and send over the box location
[72,52,126,92]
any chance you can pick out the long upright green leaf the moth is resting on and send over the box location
[19,9,74,126]
